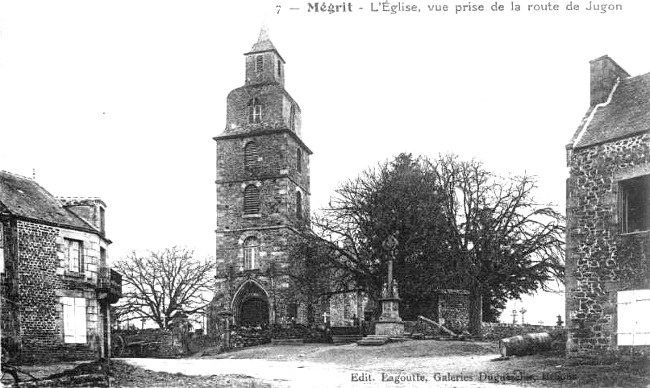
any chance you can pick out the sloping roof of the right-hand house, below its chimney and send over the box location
[573,69,650,148]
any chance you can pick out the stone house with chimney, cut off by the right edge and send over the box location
[566,56,650,355]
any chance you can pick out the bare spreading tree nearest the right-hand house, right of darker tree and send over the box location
[431,155,565,334]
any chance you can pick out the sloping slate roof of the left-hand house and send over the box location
[0,171,97,232]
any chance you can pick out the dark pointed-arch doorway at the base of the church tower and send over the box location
[232,280,269,326]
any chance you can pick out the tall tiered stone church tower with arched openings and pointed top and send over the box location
[210,27,312,325]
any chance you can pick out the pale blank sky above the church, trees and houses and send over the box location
[0,0,650,324]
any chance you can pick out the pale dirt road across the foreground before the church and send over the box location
[119,341,577,388]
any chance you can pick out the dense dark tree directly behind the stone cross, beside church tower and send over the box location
[306,154,445,316]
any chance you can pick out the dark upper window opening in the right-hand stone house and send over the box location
[619,175,650,233]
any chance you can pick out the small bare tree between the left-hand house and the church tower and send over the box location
[113,247,215,328]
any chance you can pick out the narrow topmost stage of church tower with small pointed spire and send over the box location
[244,24,285,86]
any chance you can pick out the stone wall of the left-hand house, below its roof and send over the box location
[2,219,105,362]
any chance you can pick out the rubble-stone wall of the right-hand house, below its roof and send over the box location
[566,133,650,354]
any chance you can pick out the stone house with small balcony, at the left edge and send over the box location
[0,171,121,361]
